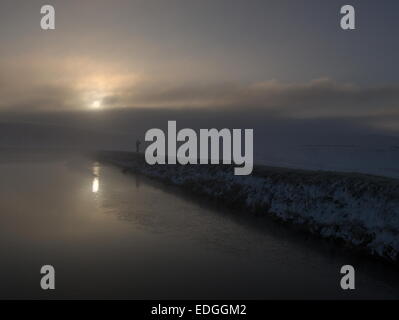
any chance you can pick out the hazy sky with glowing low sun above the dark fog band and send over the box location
[0,0,399,140]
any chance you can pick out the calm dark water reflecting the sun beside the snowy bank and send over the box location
[0,151,399,299]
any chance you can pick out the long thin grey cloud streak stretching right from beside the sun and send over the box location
[115,78,399,118]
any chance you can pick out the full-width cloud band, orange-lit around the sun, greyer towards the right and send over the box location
[0,56,399,129]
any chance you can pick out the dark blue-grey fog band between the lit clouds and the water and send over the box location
[0,108,399,178]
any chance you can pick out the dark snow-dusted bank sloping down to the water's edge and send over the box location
[99,152,399,261]
